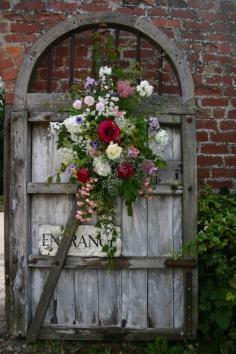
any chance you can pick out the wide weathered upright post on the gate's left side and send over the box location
[8,111,30,336]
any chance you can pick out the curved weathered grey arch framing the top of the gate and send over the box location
[14,12,194,110]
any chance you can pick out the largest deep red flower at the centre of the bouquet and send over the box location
[98,119,120,144]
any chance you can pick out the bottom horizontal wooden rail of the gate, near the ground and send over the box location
[39,325,185,342]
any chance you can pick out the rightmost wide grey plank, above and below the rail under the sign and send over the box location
[148,196,173,328]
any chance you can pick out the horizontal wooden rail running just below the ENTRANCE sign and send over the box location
[28,254,197,269]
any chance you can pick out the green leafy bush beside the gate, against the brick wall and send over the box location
[186,189,236,340]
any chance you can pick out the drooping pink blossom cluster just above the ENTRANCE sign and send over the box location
[75,178,97,222]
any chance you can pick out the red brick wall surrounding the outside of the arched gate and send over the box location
[0,0,236,189]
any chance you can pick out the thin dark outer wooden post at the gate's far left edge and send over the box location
[4,106,11,331]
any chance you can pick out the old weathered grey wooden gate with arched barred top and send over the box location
[5,13,197,341]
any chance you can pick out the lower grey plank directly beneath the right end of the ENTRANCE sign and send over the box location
[98,270,121,326]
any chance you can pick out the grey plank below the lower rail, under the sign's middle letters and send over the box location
[75,270,98,326]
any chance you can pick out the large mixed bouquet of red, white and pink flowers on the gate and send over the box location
[48,66,168,258]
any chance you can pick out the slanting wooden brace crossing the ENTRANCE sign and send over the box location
[27,208,78,342]
